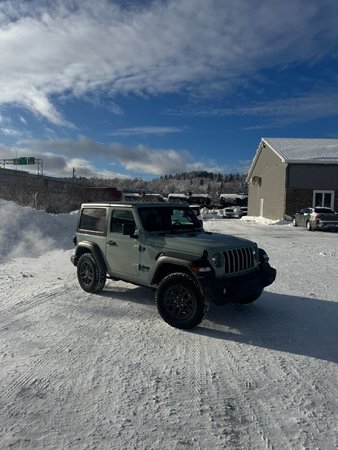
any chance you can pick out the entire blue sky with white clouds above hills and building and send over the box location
[0,0,338,179]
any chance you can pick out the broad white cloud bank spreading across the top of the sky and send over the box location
[0,0,338,126]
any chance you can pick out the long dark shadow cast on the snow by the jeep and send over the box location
[101,287,338,363]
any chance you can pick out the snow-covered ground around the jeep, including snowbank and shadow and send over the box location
[0,201,338,450]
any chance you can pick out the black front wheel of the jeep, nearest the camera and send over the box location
[155,273,208,329]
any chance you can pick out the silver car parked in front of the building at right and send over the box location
[292,206,338,231]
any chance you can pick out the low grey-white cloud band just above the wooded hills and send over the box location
[19,136,237,178]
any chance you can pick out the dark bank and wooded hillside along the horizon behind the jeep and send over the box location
[0,169,247,213]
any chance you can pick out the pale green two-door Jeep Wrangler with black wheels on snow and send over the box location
[71,202,276,329]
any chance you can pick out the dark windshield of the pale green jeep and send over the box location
[139,206,201,231]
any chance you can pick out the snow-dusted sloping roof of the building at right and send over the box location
[262,138,338,164]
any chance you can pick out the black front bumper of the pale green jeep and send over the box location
[198,262,277,305]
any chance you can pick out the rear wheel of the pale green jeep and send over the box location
[77,253,106,293]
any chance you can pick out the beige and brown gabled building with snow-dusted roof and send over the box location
[247,138,338,220]
